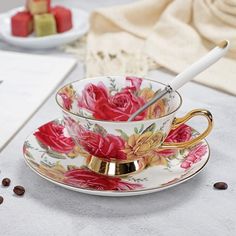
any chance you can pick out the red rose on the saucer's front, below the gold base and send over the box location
[64,168,142,191]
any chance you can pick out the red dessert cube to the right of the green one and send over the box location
[51,6,72,33]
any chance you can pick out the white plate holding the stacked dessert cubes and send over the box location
[0,7,89,49]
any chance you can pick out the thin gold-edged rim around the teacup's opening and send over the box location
[55,76,183,124]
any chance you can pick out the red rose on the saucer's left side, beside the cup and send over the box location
[34,122,75,153]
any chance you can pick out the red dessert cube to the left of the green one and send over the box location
[11,11,33,37]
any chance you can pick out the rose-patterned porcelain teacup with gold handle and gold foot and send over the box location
[56,76,213,176]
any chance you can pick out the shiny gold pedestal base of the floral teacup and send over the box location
[87,156,145,176]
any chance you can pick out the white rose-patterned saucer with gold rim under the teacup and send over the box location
[23,119,210,197]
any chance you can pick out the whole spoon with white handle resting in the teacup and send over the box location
[128,40,229,121]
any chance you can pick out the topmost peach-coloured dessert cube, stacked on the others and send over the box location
[26,0,50,15]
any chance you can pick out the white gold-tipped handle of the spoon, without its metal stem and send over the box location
[169,40,229,90]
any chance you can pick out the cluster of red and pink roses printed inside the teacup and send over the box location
[78,77,145,121]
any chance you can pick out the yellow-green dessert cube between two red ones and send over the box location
[34,13,57,37]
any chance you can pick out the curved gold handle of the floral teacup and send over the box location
[160,109,213,149]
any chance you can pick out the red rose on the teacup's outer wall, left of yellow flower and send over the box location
[77,126,126,160]
